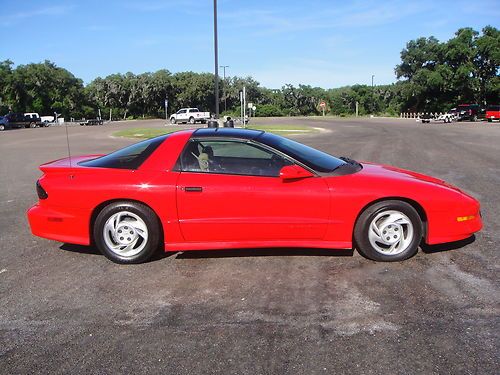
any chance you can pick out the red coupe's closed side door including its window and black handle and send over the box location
[176,139,330,242]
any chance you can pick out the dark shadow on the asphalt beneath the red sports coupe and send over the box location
[59,235,476,262]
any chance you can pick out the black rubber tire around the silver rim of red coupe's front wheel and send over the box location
[354,200,423,262]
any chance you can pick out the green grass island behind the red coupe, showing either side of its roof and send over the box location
[113,124,318,139]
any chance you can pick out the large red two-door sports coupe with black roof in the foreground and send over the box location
[28,128,482,263]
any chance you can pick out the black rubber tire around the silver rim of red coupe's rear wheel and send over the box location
[93,201,161,264]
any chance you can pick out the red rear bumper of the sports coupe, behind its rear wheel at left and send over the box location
[27,204,90,245]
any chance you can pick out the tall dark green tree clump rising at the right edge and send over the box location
[395,26,500,111]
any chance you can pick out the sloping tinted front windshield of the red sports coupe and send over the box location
[257,133,346,173]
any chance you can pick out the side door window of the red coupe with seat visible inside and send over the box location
[180,140,293,177]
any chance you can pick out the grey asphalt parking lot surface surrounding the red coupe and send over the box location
[0,118,500,374]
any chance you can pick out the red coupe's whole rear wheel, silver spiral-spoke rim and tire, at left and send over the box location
[93,202,160,264]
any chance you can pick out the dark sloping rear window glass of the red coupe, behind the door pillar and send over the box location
[78,135,168,169]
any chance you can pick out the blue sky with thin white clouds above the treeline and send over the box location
[0,0,500,88]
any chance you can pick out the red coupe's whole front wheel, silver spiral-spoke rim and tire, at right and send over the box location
[354,200,422,262]
